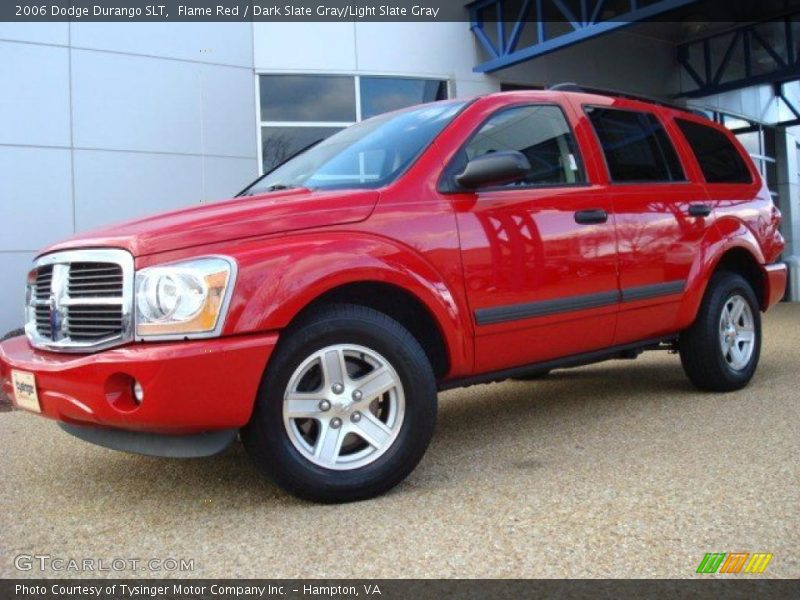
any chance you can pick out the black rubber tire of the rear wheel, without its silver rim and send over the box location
[678,271,761,392]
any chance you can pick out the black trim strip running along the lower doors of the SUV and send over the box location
[475,279,686,325]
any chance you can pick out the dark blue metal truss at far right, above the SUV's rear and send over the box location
[678,12,800,98]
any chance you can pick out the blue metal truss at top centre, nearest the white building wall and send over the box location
[467,0,697,73]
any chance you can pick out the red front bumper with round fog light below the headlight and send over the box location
[0,333,278,435]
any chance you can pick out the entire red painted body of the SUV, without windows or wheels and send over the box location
[0,92,786,433]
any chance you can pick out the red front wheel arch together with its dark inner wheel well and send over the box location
[226,232,472,378]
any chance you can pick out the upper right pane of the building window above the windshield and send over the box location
[361,77,447,119]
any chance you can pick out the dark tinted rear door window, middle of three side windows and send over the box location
[586,106,685,183]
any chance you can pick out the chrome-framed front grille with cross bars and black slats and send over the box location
[25,250,133,352]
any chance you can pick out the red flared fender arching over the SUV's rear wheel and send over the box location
[677,218,765,330]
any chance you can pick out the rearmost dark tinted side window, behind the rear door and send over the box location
[675,119,753,183]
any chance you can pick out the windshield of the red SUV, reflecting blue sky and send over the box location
[241,101,465,196]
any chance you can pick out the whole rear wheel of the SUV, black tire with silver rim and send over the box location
[678,271,761,392]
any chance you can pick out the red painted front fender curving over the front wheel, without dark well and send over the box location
[219,232,472,375]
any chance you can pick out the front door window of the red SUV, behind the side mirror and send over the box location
[458,105,585,187]
